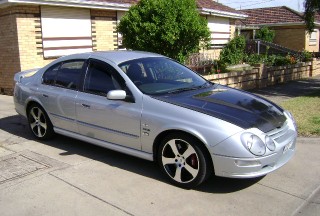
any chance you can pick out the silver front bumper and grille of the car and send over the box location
[212,119,297,178]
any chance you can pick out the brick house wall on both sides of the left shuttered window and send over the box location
[0,5,118,95]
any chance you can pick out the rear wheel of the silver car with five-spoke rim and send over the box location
[28,104,55,140]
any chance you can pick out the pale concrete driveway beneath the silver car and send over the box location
[0,95,320,216]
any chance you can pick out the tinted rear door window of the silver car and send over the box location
[43,60,84,90]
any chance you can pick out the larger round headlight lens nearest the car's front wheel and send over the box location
[241,132,266,156]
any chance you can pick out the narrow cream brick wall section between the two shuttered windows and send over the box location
[91,10,118,51]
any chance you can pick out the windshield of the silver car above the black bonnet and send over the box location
[119,57,209,95]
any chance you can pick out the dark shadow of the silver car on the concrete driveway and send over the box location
[0,115,261,193]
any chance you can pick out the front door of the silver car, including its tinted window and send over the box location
[76,59,142,149]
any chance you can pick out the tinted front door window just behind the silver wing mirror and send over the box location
[84,60,121,95]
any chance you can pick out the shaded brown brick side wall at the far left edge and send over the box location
[0,8,20,94]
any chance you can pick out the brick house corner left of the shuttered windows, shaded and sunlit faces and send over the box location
[0,6,52,94]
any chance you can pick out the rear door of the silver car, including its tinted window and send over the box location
[39,60,86,132]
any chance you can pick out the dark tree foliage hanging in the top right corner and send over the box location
[304,0,320,32]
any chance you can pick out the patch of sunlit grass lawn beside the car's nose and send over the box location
[280,90,320,137]
